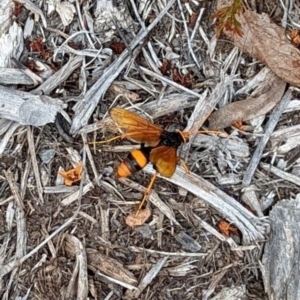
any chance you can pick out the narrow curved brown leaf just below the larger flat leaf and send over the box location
[209,71,286,130]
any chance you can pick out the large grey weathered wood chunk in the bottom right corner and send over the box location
[261,194,300,300]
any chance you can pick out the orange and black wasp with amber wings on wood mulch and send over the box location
[102,107,190,210]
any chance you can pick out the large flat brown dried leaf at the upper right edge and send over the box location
[224,10,300,87]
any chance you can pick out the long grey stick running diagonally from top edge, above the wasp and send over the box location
[70,0,175,134]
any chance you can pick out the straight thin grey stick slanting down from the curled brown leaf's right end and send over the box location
[243,90,292,186]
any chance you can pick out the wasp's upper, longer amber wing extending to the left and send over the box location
[109,107,163,147]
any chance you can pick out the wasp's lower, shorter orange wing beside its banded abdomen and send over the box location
[150,146,177,177]
